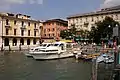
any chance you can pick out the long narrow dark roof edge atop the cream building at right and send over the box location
[67,9,120,19]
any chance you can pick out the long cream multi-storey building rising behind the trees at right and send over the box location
[67,6,120,31]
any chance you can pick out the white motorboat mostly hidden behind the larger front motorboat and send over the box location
[25,43,53,57]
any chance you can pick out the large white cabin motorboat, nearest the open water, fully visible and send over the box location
[32,42,74,60]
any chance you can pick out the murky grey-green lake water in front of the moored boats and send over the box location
[0,52,113,80]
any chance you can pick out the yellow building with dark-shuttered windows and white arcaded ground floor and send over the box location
[0,13,42,49]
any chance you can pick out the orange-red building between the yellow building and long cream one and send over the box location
[42,19,68,40]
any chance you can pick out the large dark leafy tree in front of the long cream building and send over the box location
[89,17,119,43]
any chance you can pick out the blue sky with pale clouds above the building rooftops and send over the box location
[0,0,120,20]
